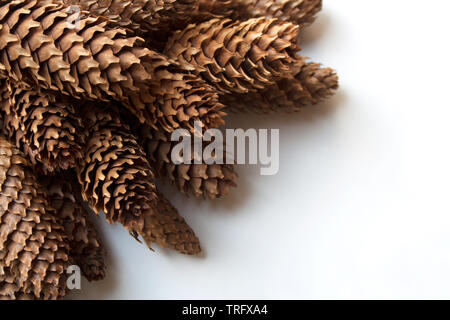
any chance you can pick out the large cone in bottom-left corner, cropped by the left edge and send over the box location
[0,136,69,299]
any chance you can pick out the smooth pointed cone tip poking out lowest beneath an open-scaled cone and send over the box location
[138,191,201,255]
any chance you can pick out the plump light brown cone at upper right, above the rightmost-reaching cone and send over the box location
[164,18,299,93]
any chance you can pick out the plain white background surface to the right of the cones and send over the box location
[72,0,450,299]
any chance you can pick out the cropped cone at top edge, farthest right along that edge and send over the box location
[231,0,322,26]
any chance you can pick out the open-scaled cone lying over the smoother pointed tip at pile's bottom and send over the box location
[78,105,155,228]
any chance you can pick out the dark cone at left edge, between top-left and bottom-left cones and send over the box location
[0,81,85,174]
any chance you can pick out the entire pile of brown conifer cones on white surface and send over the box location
[0,0,338,299]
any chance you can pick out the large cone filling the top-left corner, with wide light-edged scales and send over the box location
[0,0,142,115]
